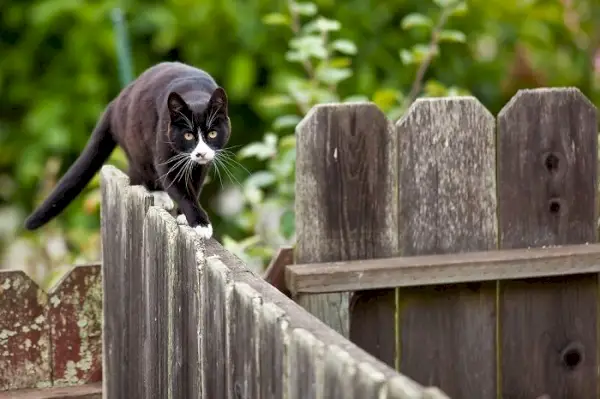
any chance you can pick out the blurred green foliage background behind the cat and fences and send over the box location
[0,0,600,287]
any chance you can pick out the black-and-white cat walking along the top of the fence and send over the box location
[25,62,231,239]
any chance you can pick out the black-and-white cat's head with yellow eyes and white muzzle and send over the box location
[167,87,231,165]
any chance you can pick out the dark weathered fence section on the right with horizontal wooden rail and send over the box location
[286,88,600,399]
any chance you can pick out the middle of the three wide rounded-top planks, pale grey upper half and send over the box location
[397,97,497,399]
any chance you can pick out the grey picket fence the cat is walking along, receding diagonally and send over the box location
[101,166,445,399]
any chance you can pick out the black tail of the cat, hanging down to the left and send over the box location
[25,103,117,230]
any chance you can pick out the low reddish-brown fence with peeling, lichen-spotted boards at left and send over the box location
[0,265,102,399]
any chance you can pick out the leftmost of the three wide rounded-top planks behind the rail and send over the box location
[296,104,397,364]
